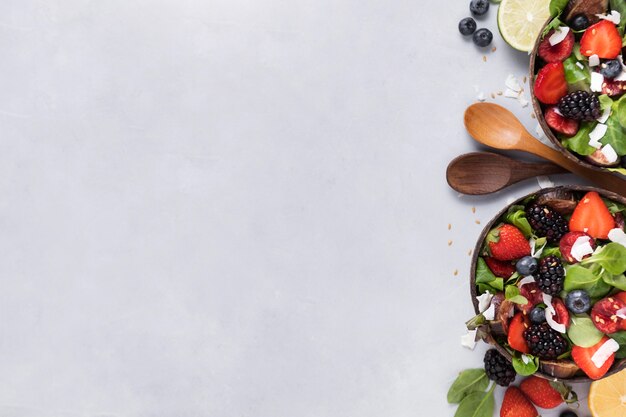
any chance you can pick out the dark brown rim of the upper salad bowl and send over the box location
[528,17,624,177]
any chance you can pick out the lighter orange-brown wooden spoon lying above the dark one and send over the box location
[465,103,626,196]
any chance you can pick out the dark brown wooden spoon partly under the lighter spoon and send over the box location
[446,152,567,195]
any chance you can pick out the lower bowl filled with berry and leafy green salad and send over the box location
[467,186,626,380]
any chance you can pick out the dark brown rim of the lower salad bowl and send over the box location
[469,185,626,382]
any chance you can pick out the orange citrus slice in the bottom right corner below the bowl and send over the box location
[589,370,626,417]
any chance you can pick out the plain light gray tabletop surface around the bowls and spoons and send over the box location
[0,0,585,417]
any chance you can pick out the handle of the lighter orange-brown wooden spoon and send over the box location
[519,134,626,196]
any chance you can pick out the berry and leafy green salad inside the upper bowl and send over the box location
[534,0,626,174]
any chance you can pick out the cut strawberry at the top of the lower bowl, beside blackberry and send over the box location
[569,191,615,239]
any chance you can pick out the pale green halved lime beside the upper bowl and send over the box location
[498,0,550,52]
